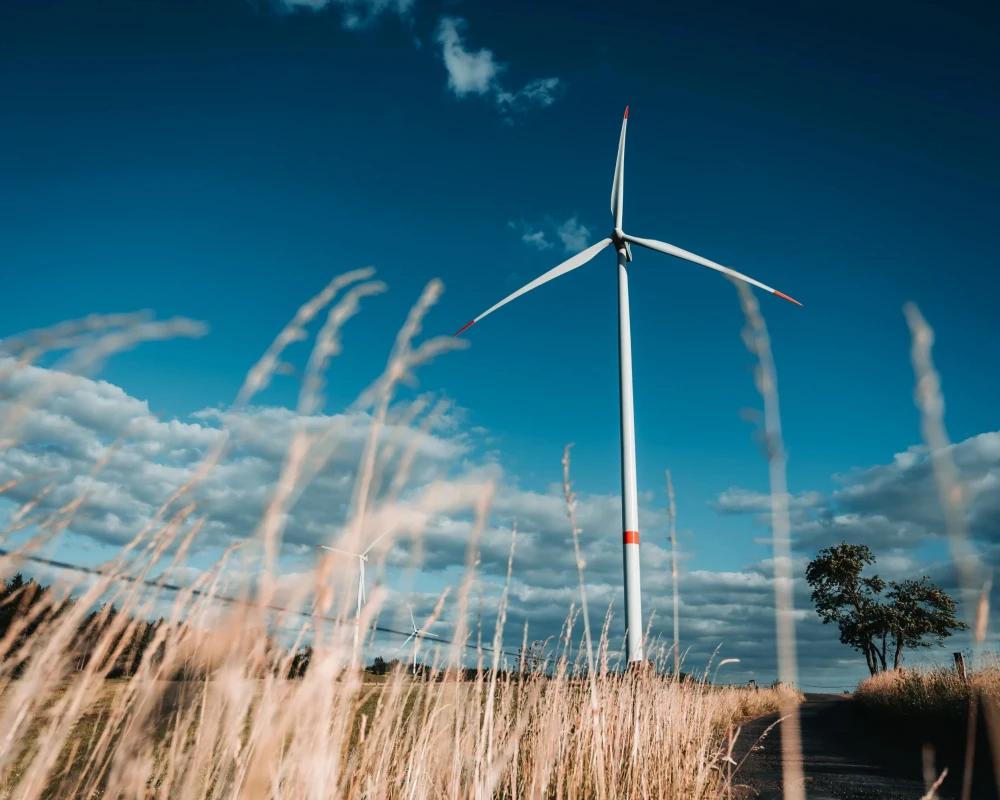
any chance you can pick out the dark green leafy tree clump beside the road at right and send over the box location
[806,542,967,675]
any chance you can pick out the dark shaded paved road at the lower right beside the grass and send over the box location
[734,694,995,800]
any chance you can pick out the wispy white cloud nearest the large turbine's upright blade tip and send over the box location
[437,17,561,112]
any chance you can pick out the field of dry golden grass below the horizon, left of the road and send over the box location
[0,670,800,798]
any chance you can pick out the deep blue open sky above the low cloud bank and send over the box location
[0,0,1000,688]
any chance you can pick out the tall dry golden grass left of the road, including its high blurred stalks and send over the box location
[0,270,798,800]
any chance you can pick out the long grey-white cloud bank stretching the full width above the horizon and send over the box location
[7,360,1000,688]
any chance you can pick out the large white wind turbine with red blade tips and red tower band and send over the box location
[455,106,802,663]
